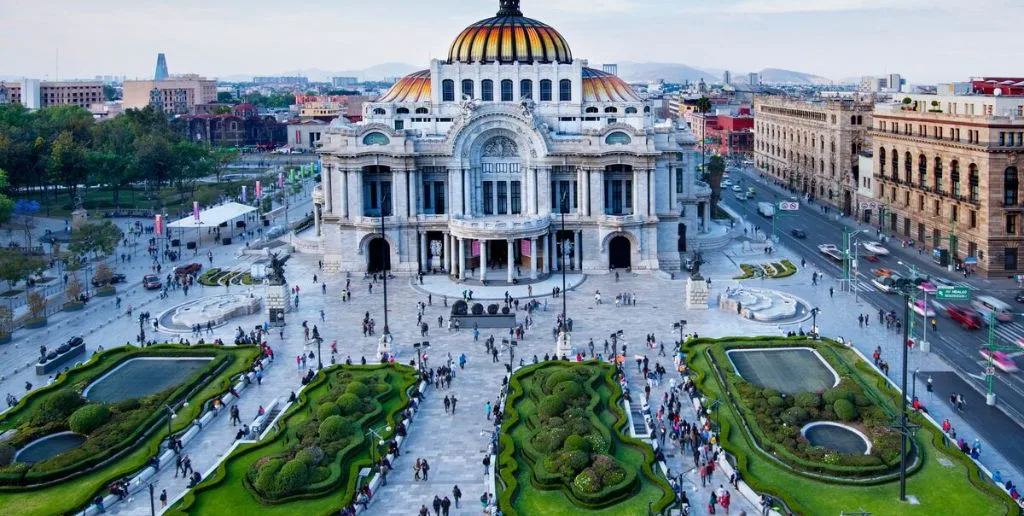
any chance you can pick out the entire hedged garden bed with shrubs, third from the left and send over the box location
[499,361,674,515]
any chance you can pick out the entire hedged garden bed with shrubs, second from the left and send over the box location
[170,364,417,515]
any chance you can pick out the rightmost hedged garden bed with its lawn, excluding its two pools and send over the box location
[683,337,1018,516]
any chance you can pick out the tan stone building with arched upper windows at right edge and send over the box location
[870,89,1024,274]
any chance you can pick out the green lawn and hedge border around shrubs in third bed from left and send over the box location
[499,361,674,515]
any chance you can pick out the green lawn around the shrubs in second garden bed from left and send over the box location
[167,364,416,516]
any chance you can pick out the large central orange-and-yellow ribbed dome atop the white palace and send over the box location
[447,0,572,65]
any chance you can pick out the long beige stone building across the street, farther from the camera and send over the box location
[754,95,872,213]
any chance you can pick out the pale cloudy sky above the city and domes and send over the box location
[0,0,1024,84]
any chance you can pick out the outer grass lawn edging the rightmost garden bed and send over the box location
[687,339,1018,515]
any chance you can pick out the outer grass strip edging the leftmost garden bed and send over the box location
[0,345,259,516]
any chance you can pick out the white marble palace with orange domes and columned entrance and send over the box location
[314,0,711,282]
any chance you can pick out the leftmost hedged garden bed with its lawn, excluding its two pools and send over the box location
[0,345,260,515]
